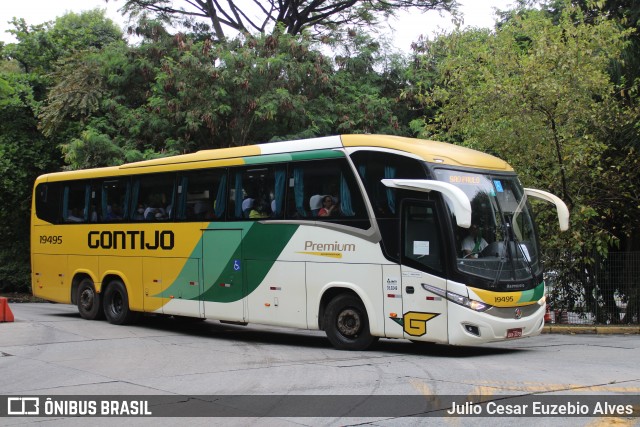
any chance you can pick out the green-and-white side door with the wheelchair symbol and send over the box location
[202,229,246,322]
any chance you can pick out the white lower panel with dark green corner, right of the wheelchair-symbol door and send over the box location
[246,260,307,329]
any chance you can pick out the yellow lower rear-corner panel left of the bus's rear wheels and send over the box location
[32,254,71,304]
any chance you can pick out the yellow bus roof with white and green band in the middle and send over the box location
[40,134,513,180]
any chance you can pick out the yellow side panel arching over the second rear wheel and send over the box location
[100,256,144,311]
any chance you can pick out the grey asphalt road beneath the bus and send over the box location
[0,303,640,426]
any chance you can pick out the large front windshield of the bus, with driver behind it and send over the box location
[435,169,541,290]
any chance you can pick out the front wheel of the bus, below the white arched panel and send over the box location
[324,294,378,350]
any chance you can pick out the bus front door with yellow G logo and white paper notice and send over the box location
[401,200,448,343]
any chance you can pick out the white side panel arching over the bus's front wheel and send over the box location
[307,262,384,337]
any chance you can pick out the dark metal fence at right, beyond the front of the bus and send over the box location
[545,252,640,325]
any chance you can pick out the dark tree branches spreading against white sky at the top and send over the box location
[122,0,457,40]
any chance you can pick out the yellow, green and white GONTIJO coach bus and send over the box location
[31,135,569,350]
